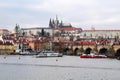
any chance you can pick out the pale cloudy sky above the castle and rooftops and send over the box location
[0,0,120,30]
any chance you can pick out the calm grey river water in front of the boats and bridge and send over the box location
[0,55,120,80]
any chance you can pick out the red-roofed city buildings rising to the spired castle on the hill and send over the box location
[0,16,120,53]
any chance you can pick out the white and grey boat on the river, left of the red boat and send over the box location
[36,51,63,58]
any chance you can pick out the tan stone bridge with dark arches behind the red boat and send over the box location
[65,45,120,56]
